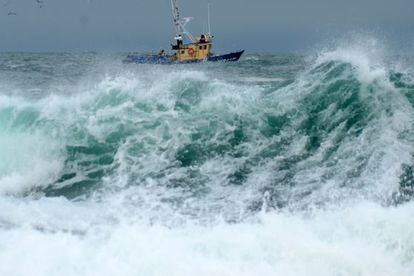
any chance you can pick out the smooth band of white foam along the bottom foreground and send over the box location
[0,201,414,276]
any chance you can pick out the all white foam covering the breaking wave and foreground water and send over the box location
[0,45,414,275]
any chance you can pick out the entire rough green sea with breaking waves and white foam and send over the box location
[0,39,414,276]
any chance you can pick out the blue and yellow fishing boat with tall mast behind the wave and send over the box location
[124,0,244,64]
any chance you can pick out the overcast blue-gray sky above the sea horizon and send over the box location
[0,0,414,53]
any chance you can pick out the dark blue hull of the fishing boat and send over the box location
[123,51,244,64]
